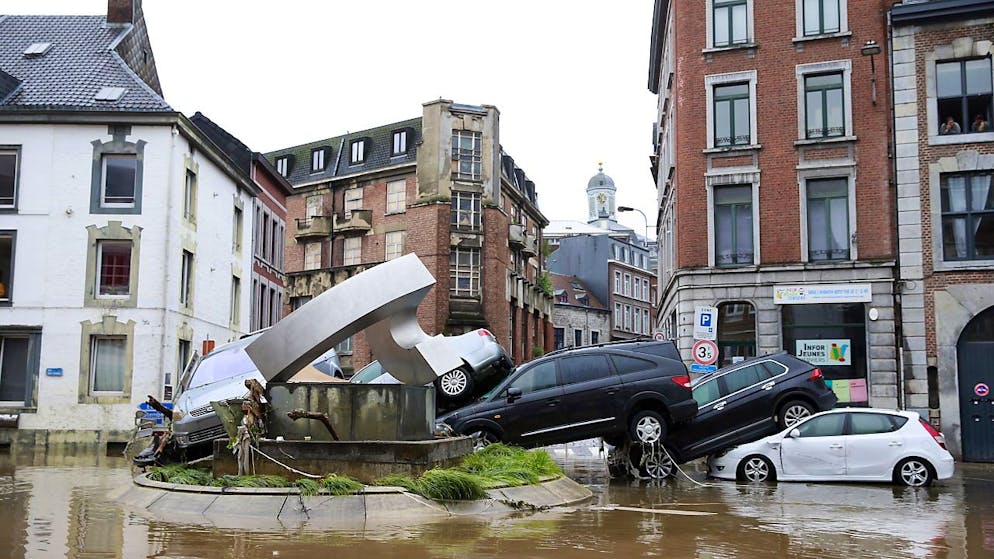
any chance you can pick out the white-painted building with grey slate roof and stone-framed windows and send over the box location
[0,0,257,448]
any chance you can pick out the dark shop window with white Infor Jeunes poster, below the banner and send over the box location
[780,303,869,405]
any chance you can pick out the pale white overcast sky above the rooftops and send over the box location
[7,0,656,236]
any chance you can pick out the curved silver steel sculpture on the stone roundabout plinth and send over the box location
[245,254,462,384]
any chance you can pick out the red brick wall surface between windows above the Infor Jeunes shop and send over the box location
[672,0,895,268]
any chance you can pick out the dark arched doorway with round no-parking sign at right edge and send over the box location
[956,307,994,462]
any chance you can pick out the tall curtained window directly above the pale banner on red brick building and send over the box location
[807,178,849,262]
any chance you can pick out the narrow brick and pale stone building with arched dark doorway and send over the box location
[891,0,994,461]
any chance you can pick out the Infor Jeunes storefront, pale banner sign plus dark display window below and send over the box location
[773,284,872,406]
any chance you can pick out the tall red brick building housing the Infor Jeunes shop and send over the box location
[649,0,898,407]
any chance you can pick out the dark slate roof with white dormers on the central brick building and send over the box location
[266,117,421,185]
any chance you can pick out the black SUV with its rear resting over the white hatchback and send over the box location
[666,352,837,462]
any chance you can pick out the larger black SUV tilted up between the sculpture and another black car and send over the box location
[439,341,697,447]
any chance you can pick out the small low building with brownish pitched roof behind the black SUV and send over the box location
[549,274,611,349]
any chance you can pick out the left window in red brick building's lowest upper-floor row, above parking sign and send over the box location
[714,186,753,266]
